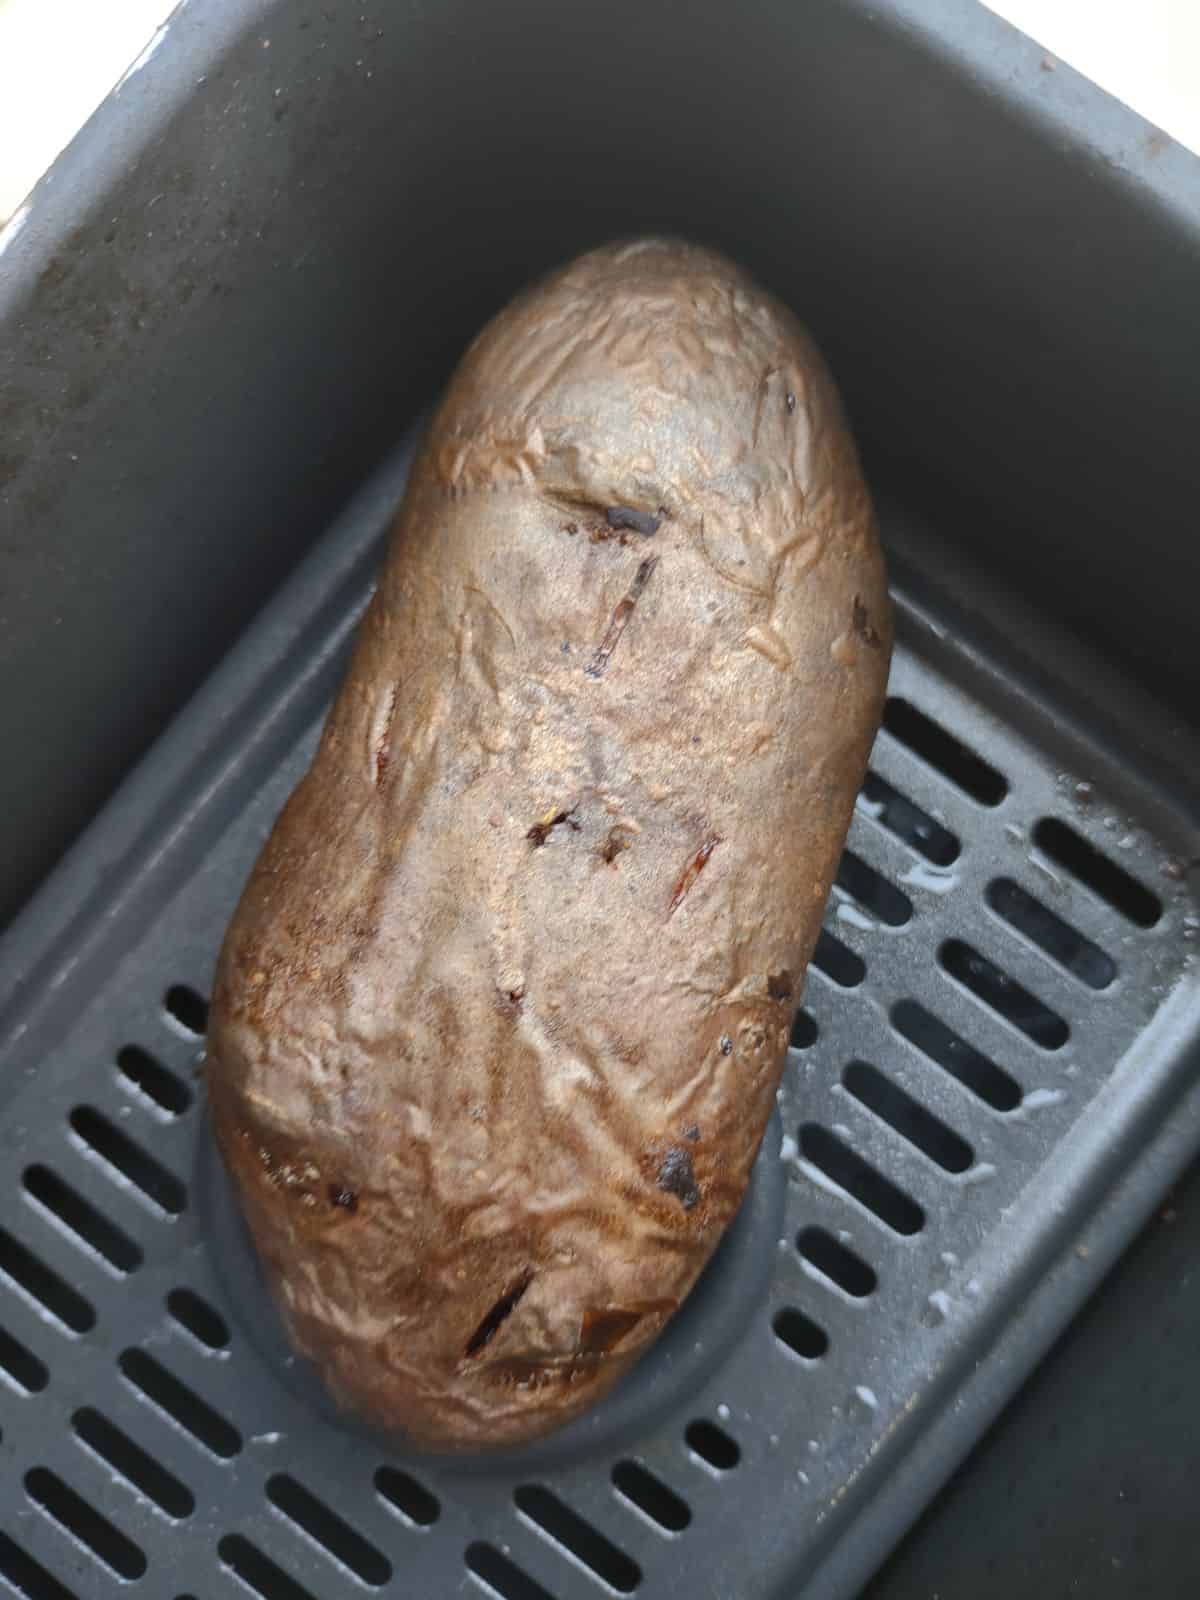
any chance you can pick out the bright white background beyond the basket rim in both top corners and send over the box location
[0,0,1200,222]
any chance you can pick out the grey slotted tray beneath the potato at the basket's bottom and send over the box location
[0,438,1200,1600]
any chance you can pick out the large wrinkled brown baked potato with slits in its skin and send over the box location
[208,240,891,1450]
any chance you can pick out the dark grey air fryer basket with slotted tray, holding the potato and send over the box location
[0,0,1200,1600]
